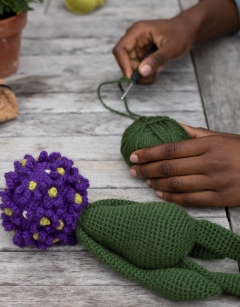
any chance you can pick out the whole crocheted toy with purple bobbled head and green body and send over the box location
[0,152,240,301]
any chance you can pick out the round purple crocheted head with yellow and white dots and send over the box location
[0,151,89,250]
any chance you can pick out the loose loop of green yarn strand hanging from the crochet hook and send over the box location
[97,77,141,119]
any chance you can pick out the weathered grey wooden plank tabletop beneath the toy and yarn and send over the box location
[0,0,239,307]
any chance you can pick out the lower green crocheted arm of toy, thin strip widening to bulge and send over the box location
[77,228,222,301]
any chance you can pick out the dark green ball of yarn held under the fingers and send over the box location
[121,116,190,166]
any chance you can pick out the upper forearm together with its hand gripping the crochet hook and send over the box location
[113,0,239,84]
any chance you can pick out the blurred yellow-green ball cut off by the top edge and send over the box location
[64,0,105,14]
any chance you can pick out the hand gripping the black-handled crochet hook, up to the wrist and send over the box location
[113,16,196,84]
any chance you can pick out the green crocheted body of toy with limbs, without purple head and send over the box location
[76,199,240,301]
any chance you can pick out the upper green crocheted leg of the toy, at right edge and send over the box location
[195,220,240,262]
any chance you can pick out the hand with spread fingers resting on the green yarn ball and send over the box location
[130,124,240,207]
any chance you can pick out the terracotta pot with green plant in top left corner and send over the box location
[0,0,43,78]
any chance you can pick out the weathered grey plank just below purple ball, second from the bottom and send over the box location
[0,232,238,286]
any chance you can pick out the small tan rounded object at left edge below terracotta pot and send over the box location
[0,79,18,123]
